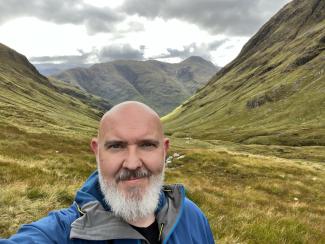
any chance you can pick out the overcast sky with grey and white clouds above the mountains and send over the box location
[0,0,290,66]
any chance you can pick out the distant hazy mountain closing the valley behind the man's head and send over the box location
[54,57,217,114]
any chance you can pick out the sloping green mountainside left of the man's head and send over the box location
[0,44,111,145]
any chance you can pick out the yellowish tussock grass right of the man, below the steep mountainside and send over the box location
[167,145,325,243]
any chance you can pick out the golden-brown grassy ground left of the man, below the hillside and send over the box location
[0,134,96,237]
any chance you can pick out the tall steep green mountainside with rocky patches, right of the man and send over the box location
[163,0,325,146]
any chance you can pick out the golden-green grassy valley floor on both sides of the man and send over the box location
[0,135,325,243]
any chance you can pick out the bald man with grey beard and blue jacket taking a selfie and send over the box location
[0,101,214,244]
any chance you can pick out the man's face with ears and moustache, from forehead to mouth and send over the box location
[92,107,169,200]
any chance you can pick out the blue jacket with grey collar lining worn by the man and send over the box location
[0,171,214,244]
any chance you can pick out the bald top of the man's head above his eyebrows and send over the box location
[98,101,163,141]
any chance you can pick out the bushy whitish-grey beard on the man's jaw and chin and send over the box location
[98,167,164,222]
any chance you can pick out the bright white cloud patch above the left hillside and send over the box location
[0,17,102,57]
